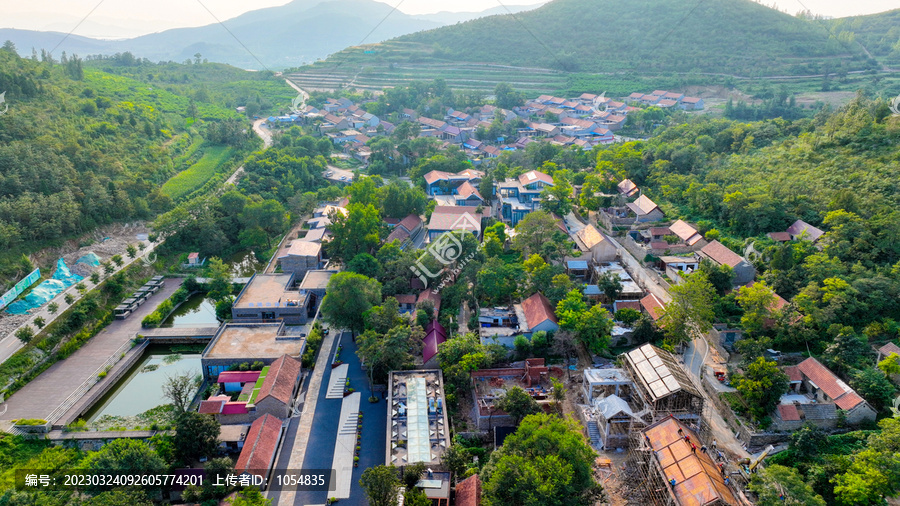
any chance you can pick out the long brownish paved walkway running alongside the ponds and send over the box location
[4,278,183,420]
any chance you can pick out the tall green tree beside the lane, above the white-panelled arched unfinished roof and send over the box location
[659,272,715,344]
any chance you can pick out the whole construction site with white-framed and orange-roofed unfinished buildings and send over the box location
[578,344,769,506]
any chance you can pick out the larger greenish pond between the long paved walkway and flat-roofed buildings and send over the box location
[84,346,200,422]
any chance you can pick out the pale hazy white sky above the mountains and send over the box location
[0,0,898,38]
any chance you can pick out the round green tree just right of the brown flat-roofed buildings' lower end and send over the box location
[319,271,381,333]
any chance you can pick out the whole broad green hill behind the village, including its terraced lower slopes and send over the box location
[295,0,878,92]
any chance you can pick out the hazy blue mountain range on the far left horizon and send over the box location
[0,0,536,70]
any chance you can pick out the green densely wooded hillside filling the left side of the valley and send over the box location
[0,44,289,287]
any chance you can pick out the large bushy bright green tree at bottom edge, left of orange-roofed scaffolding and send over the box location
[481,414,603,506]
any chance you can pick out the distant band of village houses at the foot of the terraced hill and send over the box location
[268,90,703,164]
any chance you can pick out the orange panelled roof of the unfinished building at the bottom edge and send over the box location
[643,417,739,506]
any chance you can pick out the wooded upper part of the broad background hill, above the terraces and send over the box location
[398,0,871,75]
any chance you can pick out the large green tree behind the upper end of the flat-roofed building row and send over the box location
[327,202,383,261]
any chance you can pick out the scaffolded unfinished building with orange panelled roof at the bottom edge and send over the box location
[623,416,746,506]
